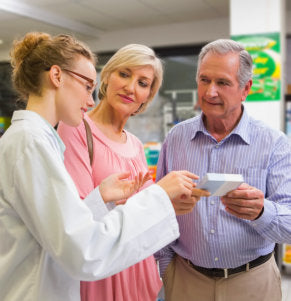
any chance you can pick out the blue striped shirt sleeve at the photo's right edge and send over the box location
[251,135,291,243]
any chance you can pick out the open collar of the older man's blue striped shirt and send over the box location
[191,106,250,144]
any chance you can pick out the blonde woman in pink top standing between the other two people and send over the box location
[59,44,205,301]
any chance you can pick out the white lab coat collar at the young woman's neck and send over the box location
[11,110,66,155]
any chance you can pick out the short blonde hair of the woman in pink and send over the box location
[98,44,163,114]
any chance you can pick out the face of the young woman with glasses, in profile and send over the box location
[56,56,96,126]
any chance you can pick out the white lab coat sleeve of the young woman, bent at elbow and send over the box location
[9,135,179,281]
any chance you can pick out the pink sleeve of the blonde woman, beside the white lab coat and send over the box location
[58,122,94,199]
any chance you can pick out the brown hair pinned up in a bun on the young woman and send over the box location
[10,32,96,101]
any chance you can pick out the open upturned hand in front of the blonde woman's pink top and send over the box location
[99,172,150,204]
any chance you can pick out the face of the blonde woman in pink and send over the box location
[105,65,154,116]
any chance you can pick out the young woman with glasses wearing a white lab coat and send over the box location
[0,33,202,301]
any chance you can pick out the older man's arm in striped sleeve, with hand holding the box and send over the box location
[222,137,291,243]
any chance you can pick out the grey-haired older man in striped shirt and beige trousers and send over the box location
[157,40,291,301]
